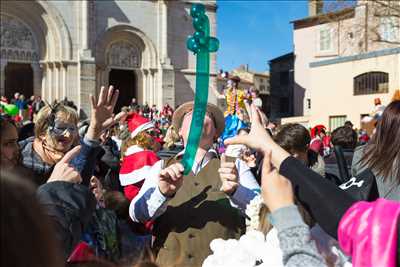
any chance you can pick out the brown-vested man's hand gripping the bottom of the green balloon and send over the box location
[158,163,184,197]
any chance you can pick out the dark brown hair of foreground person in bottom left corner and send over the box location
[0,173,64,267]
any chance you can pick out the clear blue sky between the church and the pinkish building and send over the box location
[217,0,308,72]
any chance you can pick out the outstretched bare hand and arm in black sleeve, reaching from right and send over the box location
[225,105,355,238]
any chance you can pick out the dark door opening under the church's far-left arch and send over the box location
[4,63,33,99]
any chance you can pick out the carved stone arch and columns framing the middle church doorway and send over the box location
[96,28,161,108]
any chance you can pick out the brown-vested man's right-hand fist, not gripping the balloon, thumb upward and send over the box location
[218,154,239,195]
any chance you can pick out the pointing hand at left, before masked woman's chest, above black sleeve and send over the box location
[47,146,82,183]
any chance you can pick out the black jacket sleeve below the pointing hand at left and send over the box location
[37,181,96,259]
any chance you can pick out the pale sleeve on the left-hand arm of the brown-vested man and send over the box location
[129,160,168,222]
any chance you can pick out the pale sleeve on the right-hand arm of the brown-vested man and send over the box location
[229,159,261,211]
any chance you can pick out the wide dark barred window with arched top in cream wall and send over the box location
[354,71,389,95]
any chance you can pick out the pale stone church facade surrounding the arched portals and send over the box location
[1,0,216,112]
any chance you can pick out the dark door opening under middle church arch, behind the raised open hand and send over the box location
[109,69,137,113]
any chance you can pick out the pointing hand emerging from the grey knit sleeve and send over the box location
[261,151,294,212]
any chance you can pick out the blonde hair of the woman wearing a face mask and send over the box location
[35,104,79,138]
